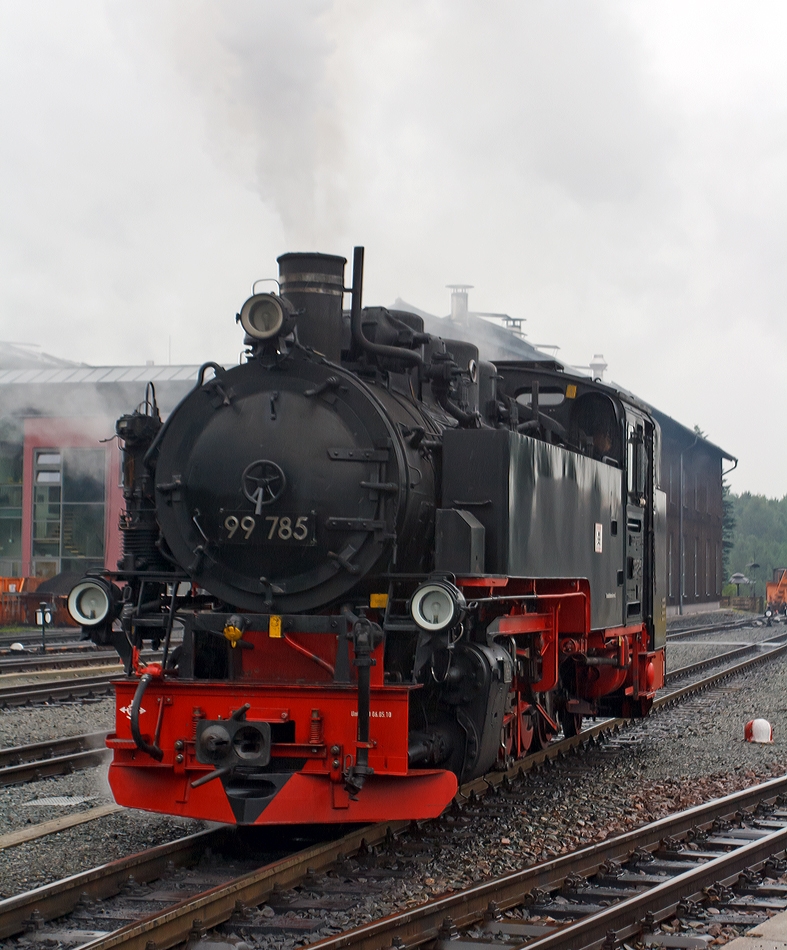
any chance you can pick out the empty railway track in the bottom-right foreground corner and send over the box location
[298,777,787,950]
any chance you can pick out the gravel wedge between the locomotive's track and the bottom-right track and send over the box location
[227,620,787,950]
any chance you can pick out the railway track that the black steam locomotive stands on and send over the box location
[0,643,787,950]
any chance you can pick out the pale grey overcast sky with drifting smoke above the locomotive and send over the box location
[0,0,787,497]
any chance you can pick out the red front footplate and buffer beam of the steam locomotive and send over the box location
[107,679,457,825]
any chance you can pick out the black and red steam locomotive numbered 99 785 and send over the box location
[69,248,666,825]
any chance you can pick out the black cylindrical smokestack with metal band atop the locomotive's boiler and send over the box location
[277,254,347,363]
